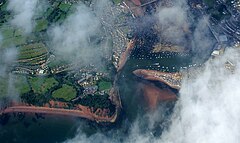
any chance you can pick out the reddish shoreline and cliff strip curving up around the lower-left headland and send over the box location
[0,85,121,123]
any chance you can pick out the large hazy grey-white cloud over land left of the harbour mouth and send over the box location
[48,3,106,66]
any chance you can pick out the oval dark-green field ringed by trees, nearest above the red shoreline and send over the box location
[52,84,77,101]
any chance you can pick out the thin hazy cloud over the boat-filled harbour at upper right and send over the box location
[156,0,216,60]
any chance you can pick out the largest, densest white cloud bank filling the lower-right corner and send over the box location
[62,47,240,143]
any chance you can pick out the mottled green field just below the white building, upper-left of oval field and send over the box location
[29,77,58,94]
